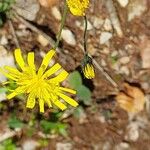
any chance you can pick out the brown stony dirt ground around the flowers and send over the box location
[0,0,150,150]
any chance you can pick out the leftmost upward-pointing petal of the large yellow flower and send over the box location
[15,48,25,70]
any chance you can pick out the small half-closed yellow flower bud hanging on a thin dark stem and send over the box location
[82,54,95,79]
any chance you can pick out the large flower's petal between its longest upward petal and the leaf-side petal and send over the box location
[43,63,61,78]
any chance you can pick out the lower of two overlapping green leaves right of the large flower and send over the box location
[77,85,91,105]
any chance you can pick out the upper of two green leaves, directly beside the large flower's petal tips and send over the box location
[69,71,82,89]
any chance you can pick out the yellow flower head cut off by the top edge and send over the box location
[67,0,89,16]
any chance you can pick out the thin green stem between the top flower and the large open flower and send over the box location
[54,0,68,49]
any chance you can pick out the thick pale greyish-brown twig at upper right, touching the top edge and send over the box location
[106,0,123,37]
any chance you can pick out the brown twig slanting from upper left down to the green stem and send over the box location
[13,12,61,52]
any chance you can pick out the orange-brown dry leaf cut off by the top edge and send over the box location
[39,0,58,8]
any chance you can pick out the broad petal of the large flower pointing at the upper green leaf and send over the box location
[48,70,69,82]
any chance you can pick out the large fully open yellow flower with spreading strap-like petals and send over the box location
[0,49,78,112]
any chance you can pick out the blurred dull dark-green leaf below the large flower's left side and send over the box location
[8,116,24,129]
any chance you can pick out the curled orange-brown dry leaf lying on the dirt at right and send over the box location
[116,83,145,113]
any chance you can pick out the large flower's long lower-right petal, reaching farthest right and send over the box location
[57,93,78,107]
